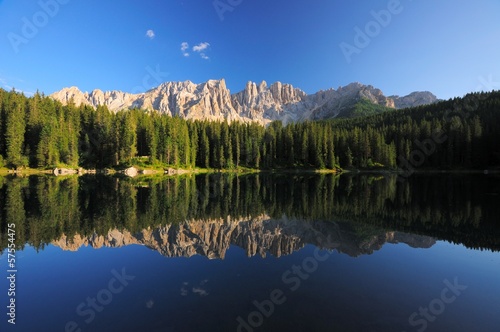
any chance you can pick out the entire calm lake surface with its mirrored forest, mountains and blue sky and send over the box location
[0,174,500,332]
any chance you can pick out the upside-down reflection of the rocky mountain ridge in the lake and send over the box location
[52,215,436,259]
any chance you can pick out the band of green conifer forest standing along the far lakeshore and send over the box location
[0,89,500,169]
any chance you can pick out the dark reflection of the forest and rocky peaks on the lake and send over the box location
[0,174,500,258]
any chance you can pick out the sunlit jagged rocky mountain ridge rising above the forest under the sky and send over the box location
[51,79,437,125]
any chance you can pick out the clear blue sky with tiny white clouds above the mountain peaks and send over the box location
[0,0,500,98]
